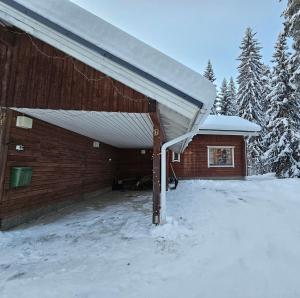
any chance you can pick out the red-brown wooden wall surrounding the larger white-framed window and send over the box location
[170,135,246,179]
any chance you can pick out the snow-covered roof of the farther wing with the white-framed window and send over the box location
[199,115,261,135]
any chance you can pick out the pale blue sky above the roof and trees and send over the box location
[72,0,286,85]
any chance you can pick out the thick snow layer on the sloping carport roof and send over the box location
[2,0,215,109]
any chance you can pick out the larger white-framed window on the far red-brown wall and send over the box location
[207,146,234,168]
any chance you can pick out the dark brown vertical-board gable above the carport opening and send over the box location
[0,26,152,113]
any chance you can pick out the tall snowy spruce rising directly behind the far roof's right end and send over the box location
[237,28,264,173]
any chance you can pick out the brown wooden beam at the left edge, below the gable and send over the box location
[0,109,13,205]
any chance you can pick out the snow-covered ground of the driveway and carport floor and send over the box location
[0,175,300,298]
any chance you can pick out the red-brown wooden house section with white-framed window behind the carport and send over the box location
[169,115,261,179]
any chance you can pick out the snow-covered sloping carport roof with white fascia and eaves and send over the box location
[0,0,216,150]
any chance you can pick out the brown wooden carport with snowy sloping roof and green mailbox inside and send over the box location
[0,0,216,229]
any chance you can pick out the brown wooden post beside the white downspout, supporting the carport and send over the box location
[152,119,162,225]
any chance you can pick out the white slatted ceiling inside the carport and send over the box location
[14,109,153,148]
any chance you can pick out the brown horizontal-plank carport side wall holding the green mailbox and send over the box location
[0,113,120,218]
